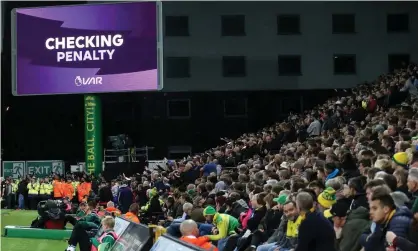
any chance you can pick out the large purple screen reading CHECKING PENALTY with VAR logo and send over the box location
[12,2,162,95]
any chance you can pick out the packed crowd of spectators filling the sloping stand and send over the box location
[2,64,418,251]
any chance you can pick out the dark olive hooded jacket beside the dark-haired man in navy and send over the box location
[338,207,371,251]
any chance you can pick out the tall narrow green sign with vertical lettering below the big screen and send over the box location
[84,95,103,174]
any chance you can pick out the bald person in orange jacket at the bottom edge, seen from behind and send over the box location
[180,220,218,251]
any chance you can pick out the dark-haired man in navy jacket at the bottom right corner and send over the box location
[360,188,412,251]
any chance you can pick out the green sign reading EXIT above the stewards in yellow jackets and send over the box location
[26,160,65,178]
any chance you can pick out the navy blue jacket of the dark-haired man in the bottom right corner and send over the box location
[360,207,412,251]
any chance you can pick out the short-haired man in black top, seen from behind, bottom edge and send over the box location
[295,192,336,251]
